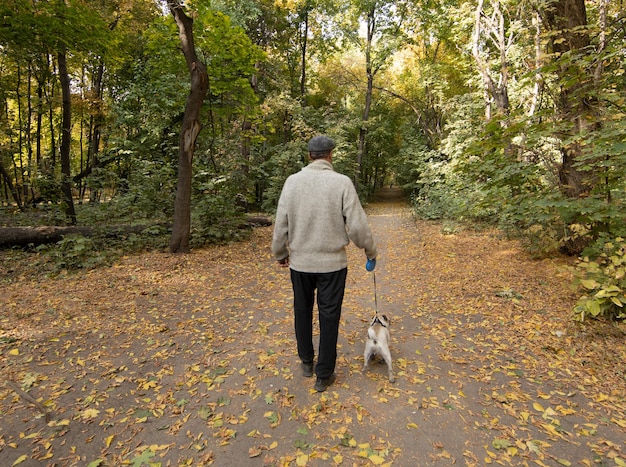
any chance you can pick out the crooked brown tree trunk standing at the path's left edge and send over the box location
[167,0,209,253]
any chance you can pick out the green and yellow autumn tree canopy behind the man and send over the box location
[0,0,626,264]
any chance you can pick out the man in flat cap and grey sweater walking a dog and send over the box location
[272,135,377,392]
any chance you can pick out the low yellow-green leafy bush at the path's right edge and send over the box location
[574,237,626,321]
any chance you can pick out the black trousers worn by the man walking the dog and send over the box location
[291,268,348,378]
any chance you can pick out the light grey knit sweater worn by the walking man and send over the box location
[272,159,377,272]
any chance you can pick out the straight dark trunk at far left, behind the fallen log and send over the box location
[58,52,76,225]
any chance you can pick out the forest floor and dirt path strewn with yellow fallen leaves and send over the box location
[0,190,626,466]
